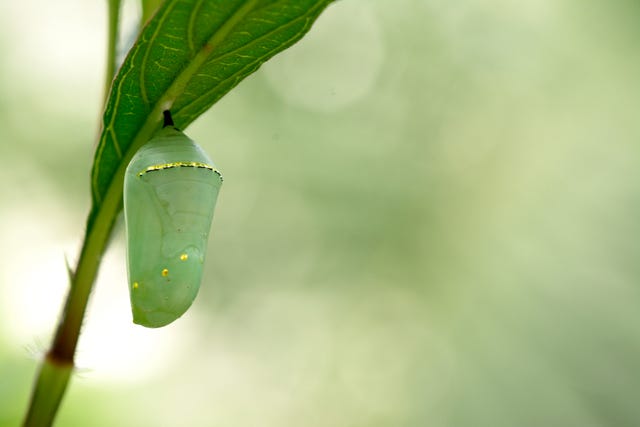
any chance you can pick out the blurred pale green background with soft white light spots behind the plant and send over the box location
[0,0,640,427]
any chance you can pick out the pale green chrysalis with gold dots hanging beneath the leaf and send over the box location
[124,111,222,328]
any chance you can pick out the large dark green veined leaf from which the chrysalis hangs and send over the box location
[87,0,332,234]
